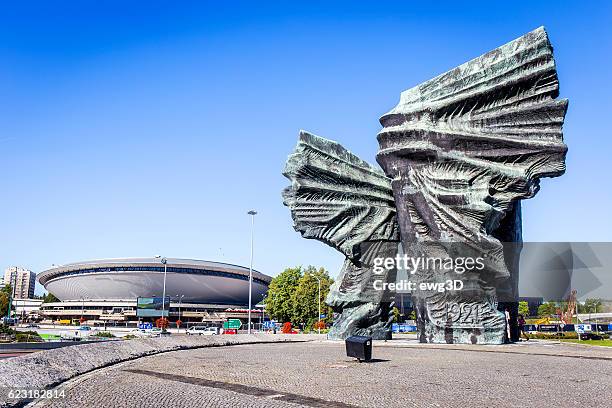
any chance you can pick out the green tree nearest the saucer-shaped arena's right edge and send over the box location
[264,266,302,323]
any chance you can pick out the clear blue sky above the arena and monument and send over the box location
[0,1,612,294]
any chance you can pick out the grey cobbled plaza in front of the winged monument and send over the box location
[35,340,612,408]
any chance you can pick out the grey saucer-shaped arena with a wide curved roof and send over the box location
[38,258,272,324]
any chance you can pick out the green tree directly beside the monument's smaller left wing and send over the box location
[291,266,333,328]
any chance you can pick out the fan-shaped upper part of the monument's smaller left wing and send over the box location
[283,131,399,259]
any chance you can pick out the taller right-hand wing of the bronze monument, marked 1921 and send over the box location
[377,28,567,344]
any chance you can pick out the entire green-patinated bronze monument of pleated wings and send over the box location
[283,28,567,344]
